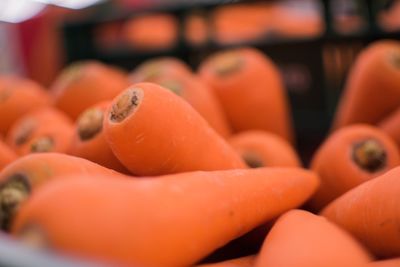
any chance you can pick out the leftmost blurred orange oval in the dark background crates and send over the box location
[121,13,178,51]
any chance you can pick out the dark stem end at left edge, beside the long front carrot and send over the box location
[0,174,30,231]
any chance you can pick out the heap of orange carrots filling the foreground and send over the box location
[0,40,400,267]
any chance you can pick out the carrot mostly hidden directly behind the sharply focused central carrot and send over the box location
[134,68,231,137]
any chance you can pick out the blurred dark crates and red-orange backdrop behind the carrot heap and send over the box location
[0,0,400,158]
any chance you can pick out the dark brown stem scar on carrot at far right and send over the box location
[353,139,387,172]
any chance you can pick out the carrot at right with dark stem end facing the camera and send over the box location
[309,124,400,213]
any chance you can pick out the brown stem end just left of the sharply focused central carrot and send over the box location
[78,108,103,141]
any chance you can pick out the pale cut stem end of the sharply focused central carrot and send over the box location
[110,88,143,122]
